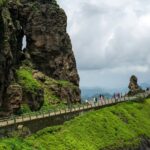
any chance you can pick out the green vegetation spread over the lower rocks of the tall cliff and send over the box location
[16,66,78,114]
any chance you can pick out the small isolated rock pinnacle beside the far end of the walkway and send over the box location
[128,75,144,96]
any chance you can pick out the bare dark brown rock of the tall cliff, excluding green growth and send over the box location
[0,0,80,116]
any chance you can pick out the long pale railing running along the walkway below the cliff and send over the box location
[0,91,150,127]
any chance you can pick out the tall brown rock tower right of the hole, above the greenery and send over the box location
[20,1,79,85]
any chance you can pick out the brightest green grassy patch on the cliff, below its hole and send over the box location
[16,67,41,93]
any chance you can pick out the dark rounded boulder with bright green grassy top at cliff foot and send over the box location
[16,67,44,111]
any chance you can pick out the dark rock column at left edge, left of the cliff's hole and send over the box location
[0,6,22,115]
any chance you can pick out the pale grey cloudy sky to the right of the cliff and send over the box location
[57,0,150,88]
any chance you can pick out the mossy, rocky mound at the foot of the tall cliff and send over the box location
[16,64,80,113]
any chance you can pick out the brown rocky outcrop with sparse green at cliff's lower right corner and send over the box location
[32,70,80,104]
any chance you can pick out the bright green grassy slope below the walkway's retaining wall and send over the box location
[0,99,150,150]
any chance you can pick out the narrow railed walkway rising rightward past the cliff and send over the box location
[0,91,150,128]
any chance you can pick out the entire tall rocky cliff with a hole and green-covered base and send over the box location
[0,0,80,115]
